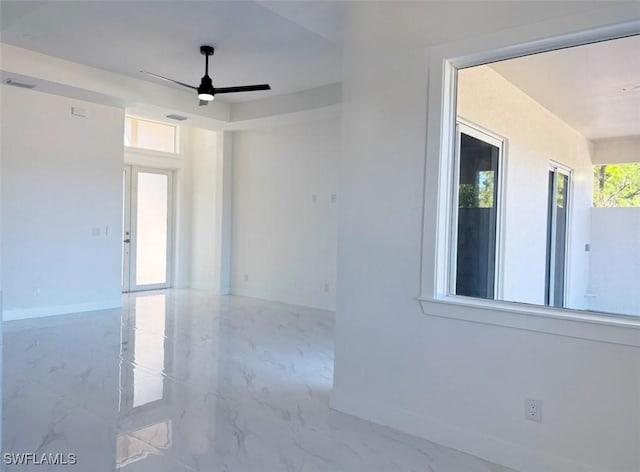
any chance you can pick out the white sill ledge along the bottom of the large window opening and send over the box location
[418,296,640,347]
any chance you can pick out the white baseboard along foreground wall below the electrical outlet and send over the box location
[331,389,611,472]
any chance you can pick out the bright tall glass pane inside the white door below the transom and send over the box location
[136,172,169,286]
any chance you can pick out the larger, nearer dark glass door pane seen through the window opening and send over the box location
[456,133,500,298]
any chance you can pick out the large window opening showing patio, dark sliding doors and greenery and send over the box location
[448,35,640,316]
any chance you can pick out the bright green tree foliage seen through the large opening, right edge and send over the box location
[593,163,640,207]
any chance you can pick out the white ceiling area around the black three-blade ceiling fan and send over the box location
[0,0,343,102]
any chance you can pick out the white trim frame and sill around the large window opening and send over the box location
[418,15,640,347]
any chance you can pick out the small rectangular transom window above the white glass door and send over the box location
[124,116,178,154]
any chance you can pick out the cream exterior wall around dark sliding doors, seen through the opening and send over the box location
[457,66,593,309]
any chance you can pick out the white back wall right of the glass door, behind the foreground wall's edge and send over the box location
[231,119,340,310]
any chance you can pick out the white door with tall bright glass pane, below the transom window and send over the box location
[122,166,173,292]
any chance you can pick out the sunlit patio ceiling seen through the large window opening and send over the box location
[491,36,640,140]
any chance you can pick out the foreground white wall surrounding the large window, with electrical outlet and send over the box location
[331,2,640,472]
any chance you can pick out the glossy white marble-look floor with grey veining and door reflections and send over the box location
[2,290,507,472]
